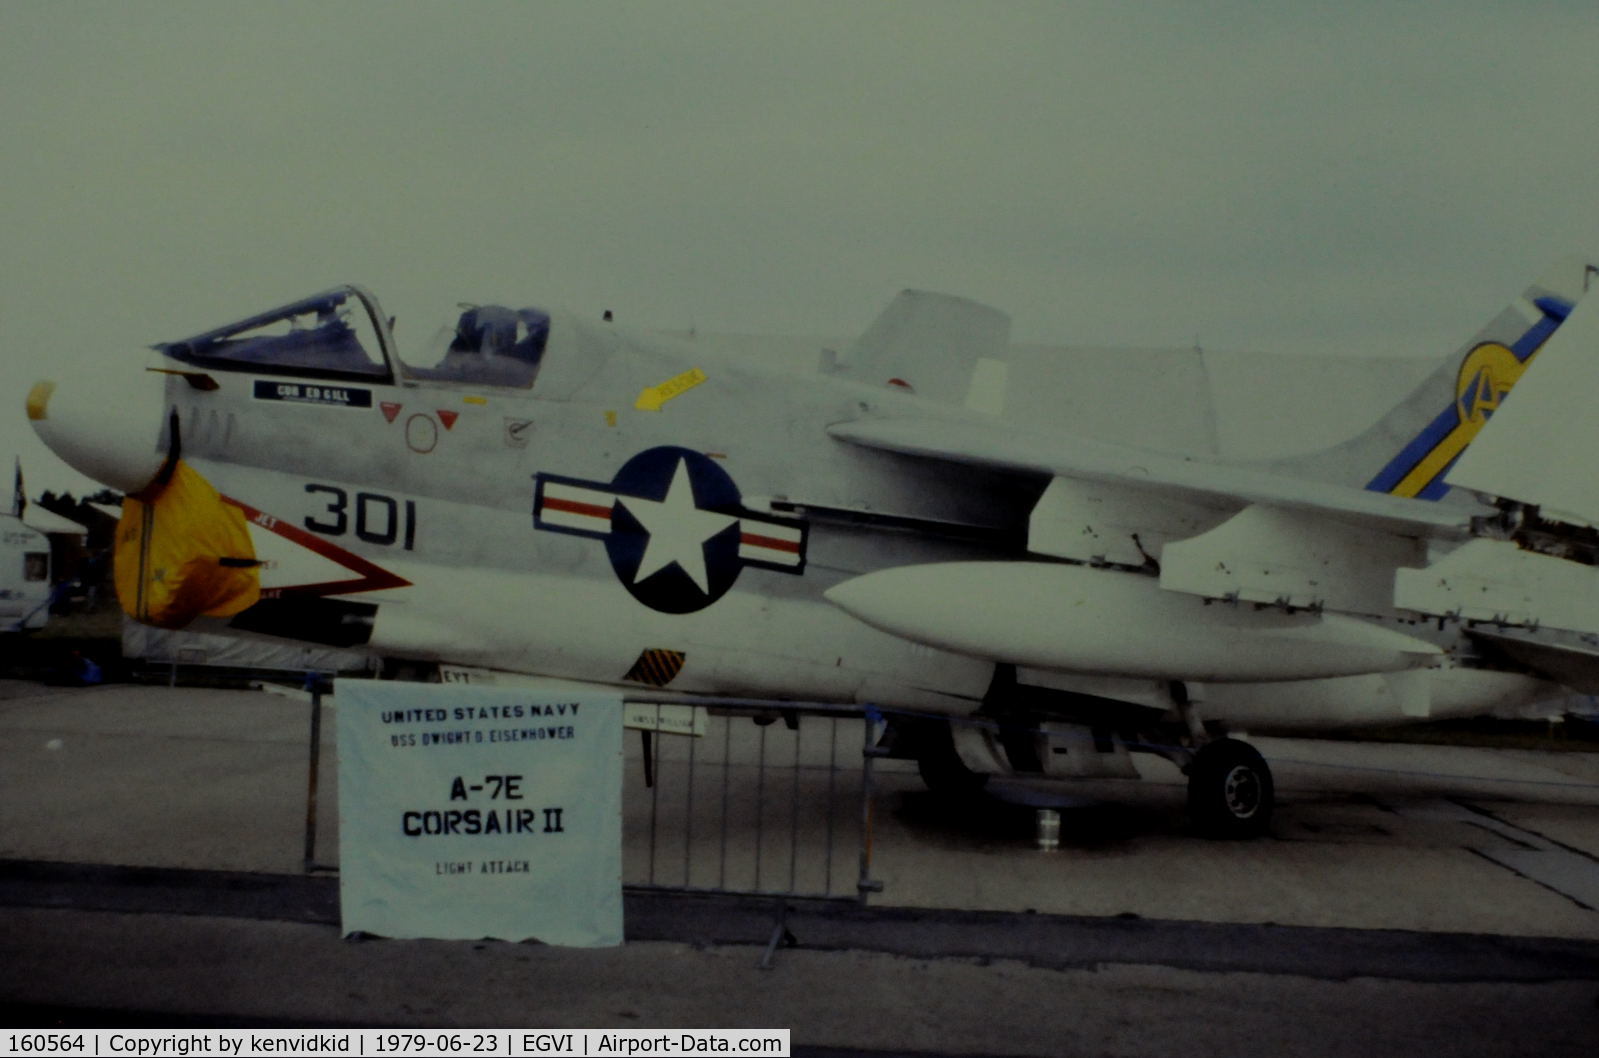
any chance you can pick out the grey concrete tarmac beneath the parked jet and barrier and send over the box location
[0,682,1599,1055]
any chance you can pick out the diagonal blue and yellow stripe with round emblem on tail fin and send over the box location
[1366,297,1572,500]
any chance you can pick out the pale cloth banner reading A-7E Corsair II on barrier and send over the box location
[336,679,622,948]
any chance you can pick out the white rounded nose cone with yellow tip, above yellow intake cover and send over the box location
[27,369,166,492]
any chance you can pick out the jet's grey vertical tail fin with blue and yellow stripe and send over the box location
[1268,257,1599,500]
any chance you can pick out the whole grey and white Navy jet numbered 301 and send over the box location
[27,264,1599,834]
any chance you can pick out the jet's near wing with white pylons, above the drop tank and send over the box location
[828,416,1473,615]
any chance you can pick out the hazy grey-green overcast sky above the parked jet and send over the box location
[0,0,1599,492]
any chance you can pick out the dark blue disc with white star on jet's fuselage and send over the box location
[604,446,742,614]
